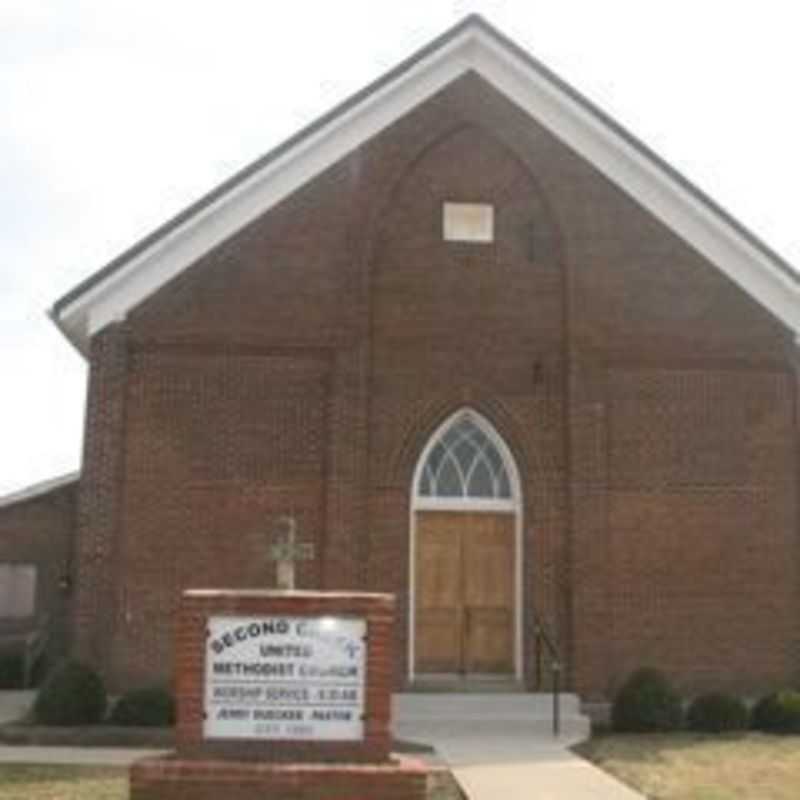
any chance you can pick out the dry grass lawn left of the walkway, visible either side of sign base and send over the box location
[0,764,461,800]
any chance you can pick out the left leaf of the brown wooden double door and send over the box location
[415,514,464,672]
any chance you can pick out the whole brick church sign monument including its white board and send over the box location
[130,590,426,800]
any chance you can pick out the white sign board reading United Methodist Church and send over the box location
[203,616,367,741]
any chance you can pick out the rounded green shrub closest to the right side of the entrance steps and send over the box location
[611,668,683,733]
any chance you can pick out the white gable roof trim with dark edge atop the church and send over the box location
[50,15,800,353]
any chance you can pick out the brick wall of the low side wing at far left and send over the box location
[0,481,77,662]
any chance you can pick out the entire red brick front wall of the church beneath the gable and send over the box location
[72,76,798,693]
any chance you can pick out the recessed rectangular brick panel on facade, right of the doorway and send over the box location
[606,368,797,692]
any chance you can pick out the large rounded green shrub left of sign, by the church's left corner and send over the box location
[33,661,107,725]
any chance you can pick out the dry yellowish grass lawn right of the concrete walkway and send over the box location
[576,733,800,800]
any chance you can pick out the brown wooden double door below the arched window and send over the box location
[414,511,516,675]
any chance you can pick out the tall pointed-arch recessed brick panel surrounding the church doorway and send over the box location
[369,125,565,675]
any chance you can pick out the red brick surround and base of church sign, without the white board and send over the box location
[130,590,427,800]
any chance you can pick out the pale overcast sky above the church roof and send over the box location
[0,0,800,495]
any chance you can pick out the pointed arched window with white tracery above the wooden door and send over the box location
[416,411,512,500]
